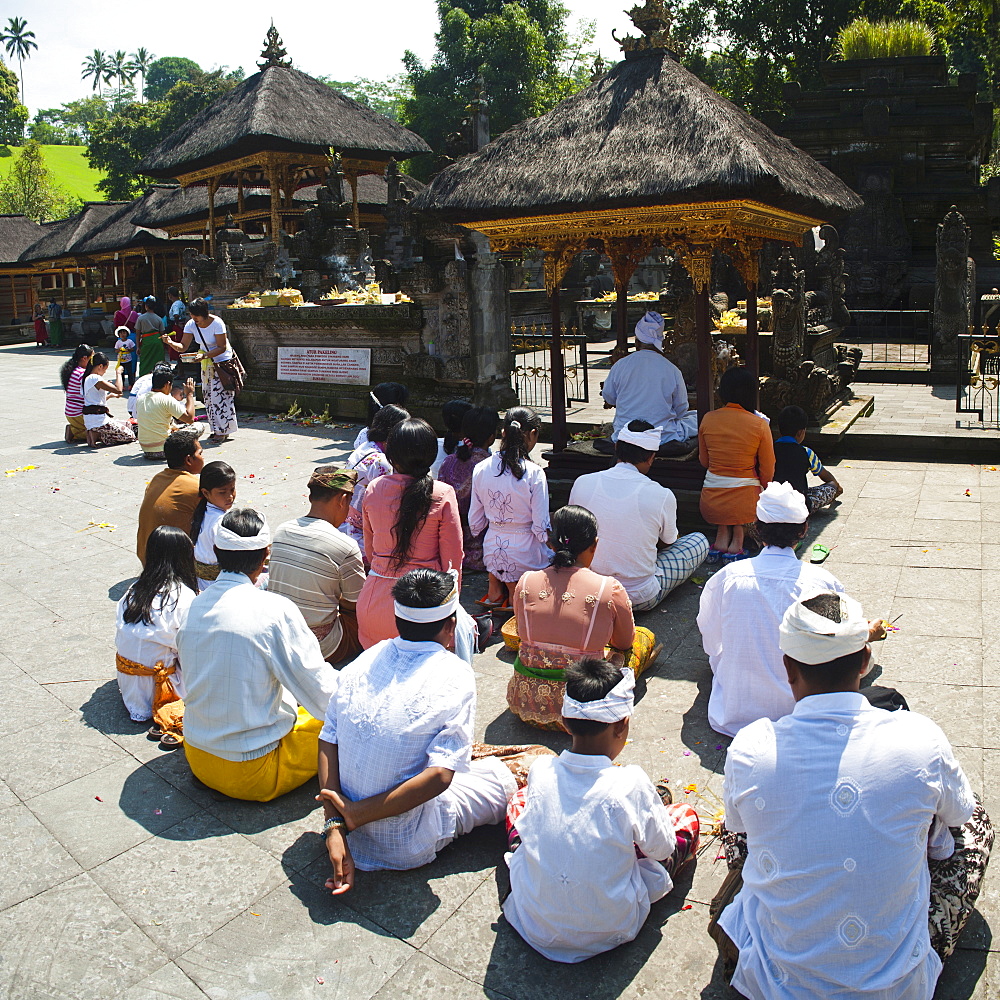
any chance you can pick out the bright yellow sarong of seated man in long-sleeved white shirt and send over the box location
[184,708,323,802]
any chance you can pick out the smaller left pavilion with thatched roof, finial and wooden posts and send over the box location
[137,24,430,253]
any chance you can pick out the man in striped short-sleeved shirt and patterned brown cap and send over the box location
[267,465,365,664]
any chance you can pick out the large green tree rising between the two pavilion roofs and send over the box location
[401,0,593,173]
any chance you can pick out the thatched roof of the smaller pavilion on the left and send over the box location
[138,66,430,178]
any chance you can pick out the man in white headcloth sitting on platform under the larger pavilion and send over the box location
[595,312,698,455]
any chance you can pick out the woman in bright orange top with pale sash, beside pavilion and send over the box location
[698,368,774,557]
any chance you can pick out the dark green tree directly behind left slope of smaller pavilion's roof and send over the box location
[87,71,237,200]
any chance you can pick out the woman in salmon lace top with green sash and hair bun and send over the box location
[507,506,656,732]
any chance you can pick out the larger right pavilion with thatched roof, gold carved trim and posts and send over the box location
[413,0,862,452]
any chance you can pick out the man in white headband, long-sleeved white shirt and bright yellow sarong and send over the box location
[177,508,337,802]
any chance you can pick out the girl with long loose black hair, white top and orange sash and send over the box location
[115,525,198,749]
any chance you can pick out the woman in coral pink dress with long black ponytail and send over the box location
[358,418,475,663]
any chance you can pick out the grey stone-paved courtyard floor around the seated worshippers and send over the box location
[0,346,1000,1000]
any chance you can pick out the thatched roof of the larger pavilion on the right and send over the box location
[413,49,862,222]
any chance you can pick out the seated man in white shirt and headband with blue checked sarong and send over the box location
[569,420,708,611]
